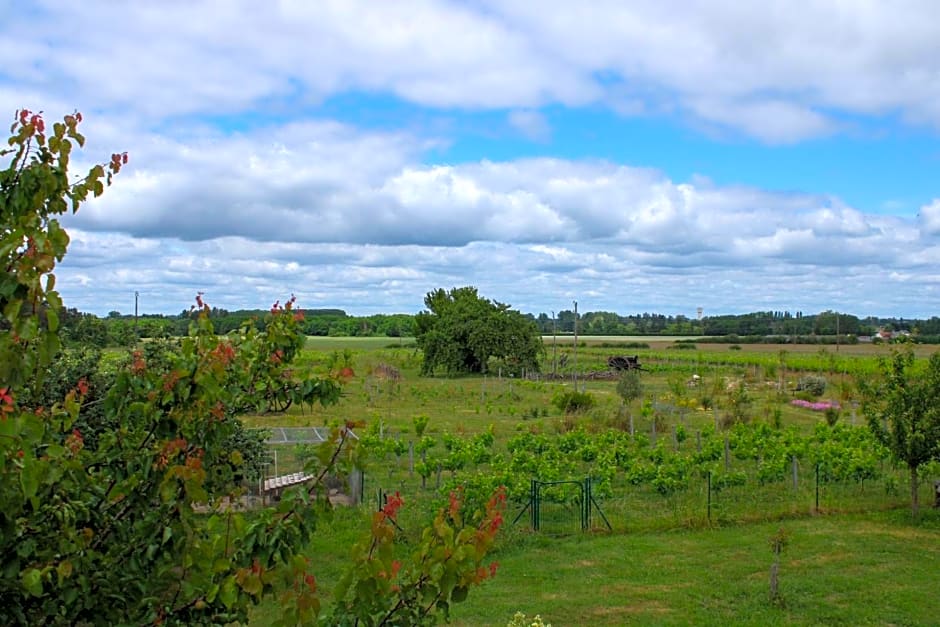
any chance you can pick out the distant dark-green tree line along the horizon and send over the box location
[60,308,940,347]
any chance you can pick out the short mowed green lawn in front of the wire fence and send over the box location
[453,510,940,627]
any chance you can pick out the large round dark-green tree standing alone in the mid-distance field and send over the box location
[415,287,545,374]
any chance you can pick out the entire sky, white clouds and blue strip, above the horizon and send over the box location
[0,0,940,317]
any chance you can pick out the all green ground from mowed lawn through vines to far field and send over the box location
[245,336,940,627]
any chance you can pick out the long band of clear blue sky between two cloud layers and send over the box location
[318,93,940,217]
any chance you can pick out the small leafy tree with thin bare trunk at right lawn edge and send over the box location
[863,348,940,516]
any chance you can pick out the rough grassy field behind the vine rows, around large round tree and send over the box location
[247,337,904,434]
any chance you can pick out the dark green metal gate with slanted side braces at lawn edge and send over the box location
[513,477,611,533]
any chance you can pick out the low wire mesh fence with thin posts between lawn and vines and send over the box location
[364,466,935,535]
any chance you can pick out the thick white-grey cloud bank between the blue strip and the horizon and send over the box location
[51,123,940,316]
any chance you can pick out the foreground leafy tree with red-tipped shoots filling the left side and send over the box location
[0,111,502,625]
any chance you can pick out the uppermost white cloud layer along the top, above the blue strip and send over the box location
[0,0,940,143]
